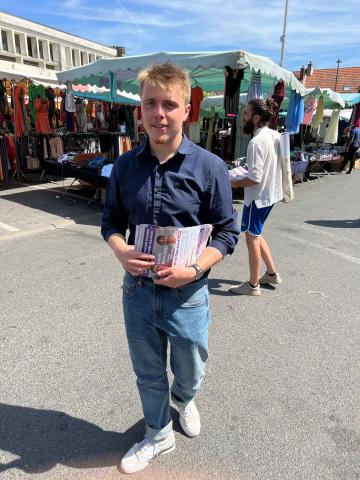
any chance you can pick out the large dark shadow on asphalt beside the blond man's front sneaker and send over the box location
[0,403,145,474]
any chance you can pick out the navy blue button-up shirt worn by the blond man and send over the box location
[101,136,239,255]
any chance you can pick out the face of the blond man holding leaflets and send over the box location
[141,84,190,145]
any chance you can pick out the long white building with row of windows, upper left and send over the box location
[0,12,124,85]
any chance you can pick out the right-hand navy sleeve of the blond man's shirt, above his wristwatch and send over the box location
[205,159,240,256]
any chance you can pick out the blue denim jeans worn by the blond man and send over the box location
[123,273,210,440]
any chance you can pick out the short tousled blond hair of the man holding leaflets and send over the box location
[138,62,191,104]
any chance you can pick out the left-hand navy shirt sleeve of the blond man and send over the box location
[101,157,129,241]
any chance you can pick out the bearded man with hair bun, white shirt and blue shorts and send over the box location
[230,99,283,296]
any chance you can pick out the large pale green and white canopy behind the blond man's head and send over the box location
[57,50,305,100]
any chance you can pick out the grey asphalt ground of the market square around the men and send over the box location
[0,171,360,480]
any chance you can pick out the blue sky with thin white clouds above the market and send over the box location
[5,0,360,70]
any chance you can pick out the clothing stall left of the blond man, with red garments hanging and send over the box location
[0,74,140,187]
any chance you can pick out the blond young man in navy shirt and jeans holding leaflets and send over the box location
[102,62,239,473]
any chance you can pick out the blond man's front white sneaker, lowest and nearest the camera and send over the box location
[120,431,175,473]
